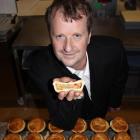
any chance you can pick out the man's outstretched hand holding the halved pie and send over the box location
[53,77,84,101]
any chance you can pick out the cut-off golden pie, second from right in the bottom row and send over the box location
[91,133,110,140]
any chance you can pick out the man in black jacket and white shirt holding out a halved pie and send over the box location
[28,0,127,130]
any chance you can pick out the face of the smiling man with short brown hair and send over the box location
[50,10,91,69]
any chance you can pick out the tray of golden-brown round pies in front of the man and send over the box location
[2,116,132,140]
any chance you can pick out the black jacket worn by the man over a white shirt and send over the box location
[27,36,128,129]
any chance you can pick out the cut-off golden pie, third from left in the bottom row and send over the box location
[46,133,65,140]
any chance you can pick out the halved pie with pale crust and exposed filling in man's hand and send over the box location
[53,80,84,93]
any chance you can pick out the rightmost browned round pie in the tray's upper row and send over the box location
[110,116,128,132]
